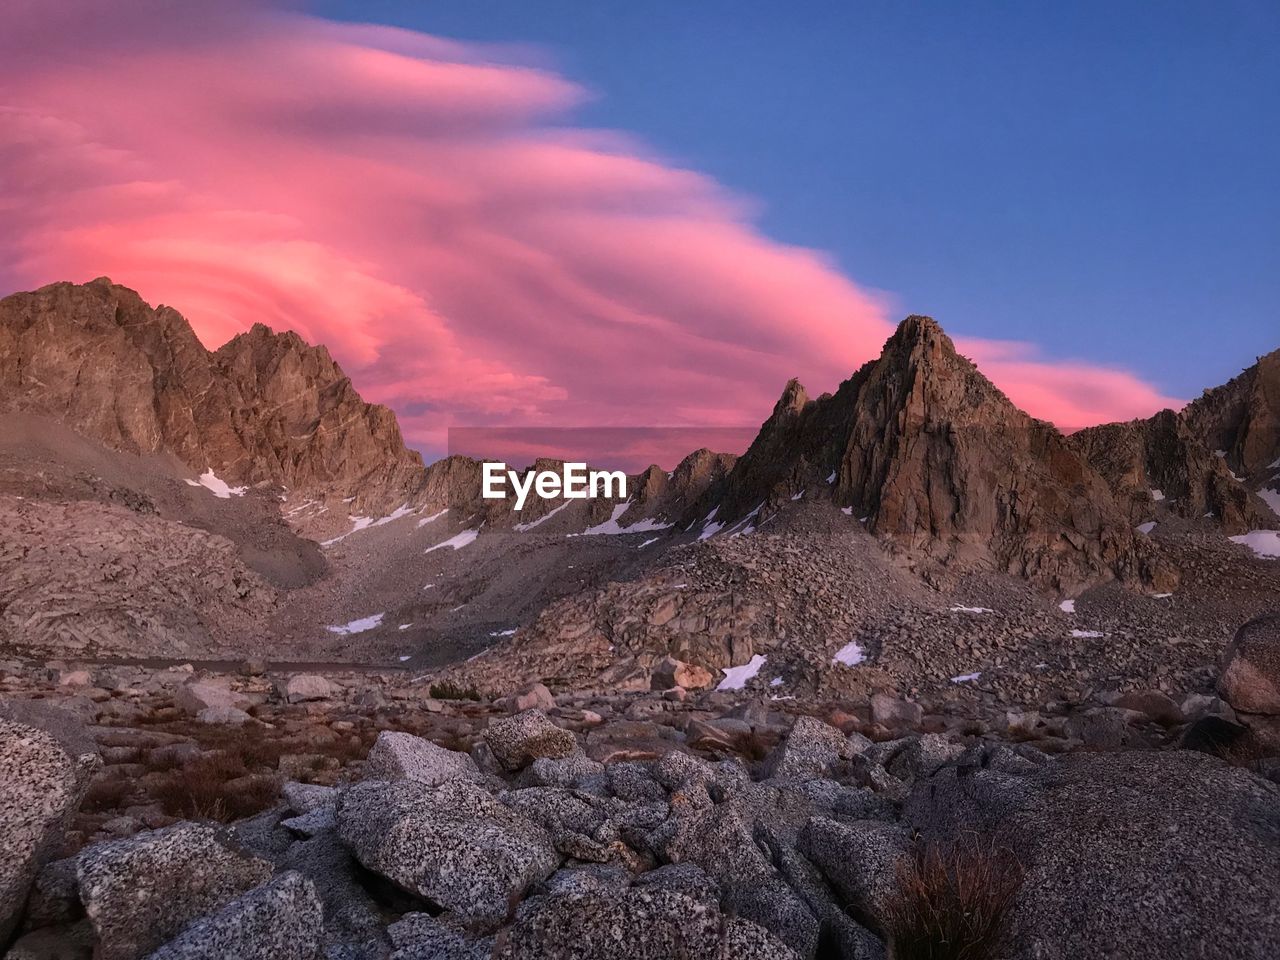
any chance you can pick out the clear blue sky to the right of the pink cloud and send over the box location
[310,0,1280,398]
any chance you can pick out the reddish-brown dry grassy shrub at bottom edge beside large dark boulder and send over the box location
[884,837,1023,960]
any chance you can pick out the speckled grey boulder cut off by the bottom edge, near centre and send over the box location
[494,887,797,960]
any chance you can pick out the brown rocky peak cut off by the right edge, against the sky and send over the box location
[1184,349,1280,477]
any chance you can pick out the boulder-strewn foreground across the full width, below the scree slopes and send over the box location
[0,618,1280,960]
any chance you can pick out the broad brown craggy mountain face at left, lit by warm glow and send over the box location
[0,278,422,504]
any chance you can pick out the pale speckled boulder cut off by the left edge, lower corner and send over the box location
[0,717,100,943]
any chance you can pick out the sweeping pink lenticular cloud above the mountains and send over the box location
[0,0,1172,465]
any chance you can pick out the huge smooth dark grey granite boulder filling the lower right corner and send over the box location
[904,750,1280,960]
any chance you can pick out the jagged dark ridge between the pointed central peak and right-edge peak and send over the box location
[1070,410,1270,534]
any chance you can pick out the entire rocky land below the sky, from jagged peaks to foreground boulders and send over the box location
[0,279,1280,960]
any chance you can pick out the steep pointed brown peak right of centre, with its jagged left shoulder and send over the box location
[719,316,1175,593]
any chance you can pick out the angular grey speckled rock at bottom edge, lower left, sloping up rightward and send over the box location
[148,872,323,960]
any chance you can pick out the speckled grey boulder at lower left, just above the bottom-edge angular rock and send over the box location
[76,823,273,960]
